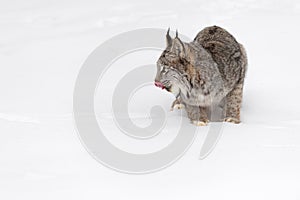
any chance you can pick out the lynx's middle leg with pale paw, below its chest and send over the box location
[185,105,209,126]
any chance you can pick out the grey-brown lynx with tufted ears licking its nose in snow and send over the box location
[155,26,247,126]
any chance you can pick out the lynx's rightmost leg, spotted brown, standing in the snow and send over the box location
[224,83,243,124]
